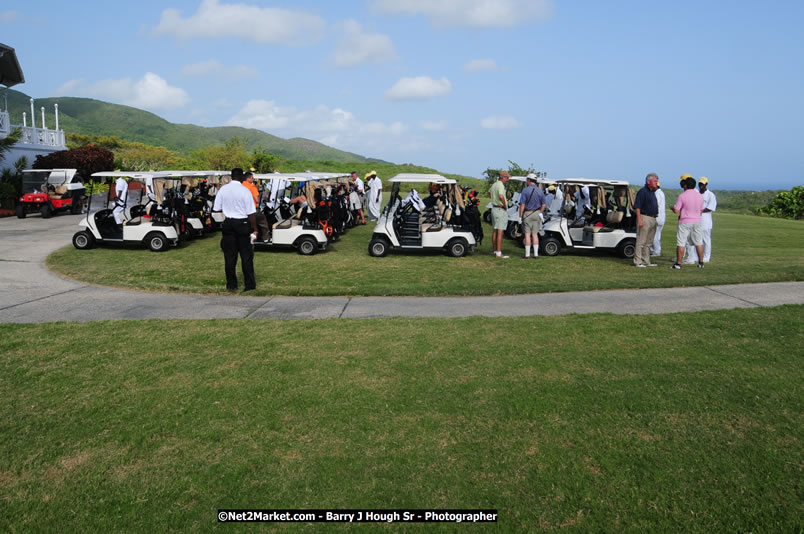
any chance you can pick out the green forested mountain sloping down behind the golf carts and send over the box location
[6,89,383,163]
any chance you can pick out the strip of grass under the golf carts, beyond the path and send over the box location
[47,213,804,296]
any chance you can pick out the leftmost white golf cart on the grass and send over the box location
[73,171,179,252]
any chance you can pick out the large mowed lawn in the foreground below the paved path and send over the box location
[0,306,804,533]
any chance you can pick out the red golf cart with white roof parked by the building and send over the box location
[16,169,86,219]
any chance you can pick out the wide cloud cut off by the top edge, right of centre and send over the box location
[373,0,553,28]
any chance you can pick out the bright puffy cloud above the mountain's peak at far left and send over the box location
[56,72,190,111]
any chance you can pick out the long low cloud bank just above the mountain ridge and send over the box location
[227,100,408,153]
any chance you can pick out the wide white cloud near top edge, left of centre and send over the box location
[154,0,326,46]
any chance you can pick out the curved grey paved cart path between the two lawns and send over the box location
[0,215,804,323]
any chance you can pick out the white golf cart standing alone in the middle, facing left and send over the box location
[368,174,477,258]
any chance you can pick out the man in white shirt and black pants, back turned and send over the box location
[212,168,257,291]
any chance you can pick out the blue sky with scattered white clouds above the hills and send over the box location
[0,0,804,189]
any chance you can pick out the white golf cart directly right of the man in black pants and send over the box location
[254,173,328,256]
